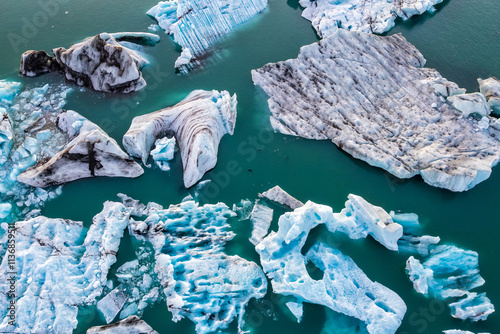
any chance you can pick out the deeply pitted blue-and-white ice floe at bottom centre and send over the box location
[122,196,267,334]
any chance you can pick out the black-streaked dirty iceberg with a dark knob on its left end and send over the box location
[19,32,160,93]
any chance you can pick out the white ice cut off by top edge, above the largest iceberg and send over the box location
[299,0,443,38]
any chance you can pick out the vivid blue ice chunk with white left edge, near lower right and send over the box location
[406,245,484,299]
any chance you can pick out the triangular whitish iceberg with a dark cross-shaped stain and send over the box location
[17,110,144,188]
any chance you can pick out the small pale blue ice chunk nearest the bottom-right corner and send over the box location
[450,292,495,321]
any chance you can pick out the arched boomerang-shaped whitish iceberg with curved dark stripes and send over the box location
[123,90,237,188]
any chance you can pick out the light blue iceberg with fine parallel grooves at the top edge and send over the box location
[147,0,267,73]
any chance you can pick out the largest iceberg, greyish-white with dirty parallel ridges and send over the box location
[252,29,500,191]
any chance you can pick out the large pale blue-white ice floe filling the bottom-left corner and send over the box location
[0,202,132,334]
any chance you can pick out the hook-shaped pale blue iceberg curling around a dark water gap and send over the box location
[256,200,406,333]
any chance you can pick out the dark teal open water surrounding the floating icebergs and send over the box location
[0,0,500,334]
